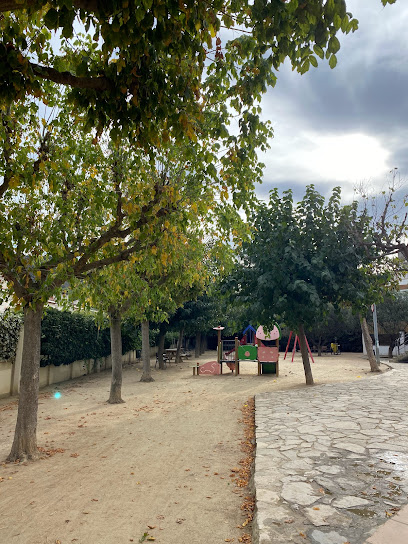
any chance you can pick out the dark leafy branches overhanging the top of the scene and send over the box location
[0,0,395,145]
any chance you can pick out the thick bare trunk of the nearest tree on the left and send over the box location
[7,304,43,462]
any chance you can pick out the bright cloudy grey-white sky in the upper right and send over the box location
[257,0,408,200]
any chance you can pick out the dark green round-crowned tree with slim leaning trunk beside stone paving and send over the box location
[234,186,388,385]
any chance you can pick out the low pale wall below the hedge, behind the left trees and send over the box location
[0,347,157,398]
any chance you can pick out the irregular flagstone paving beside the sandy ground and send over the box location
[253,365,408,544]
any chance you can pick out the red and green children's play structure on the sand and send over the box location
[197,325,280,376]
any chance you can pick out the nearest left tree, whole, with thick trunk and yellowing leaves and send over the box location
[0,96,198,460]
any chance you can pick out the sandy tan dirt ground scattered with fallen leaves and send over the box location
[0,353,382,544]
